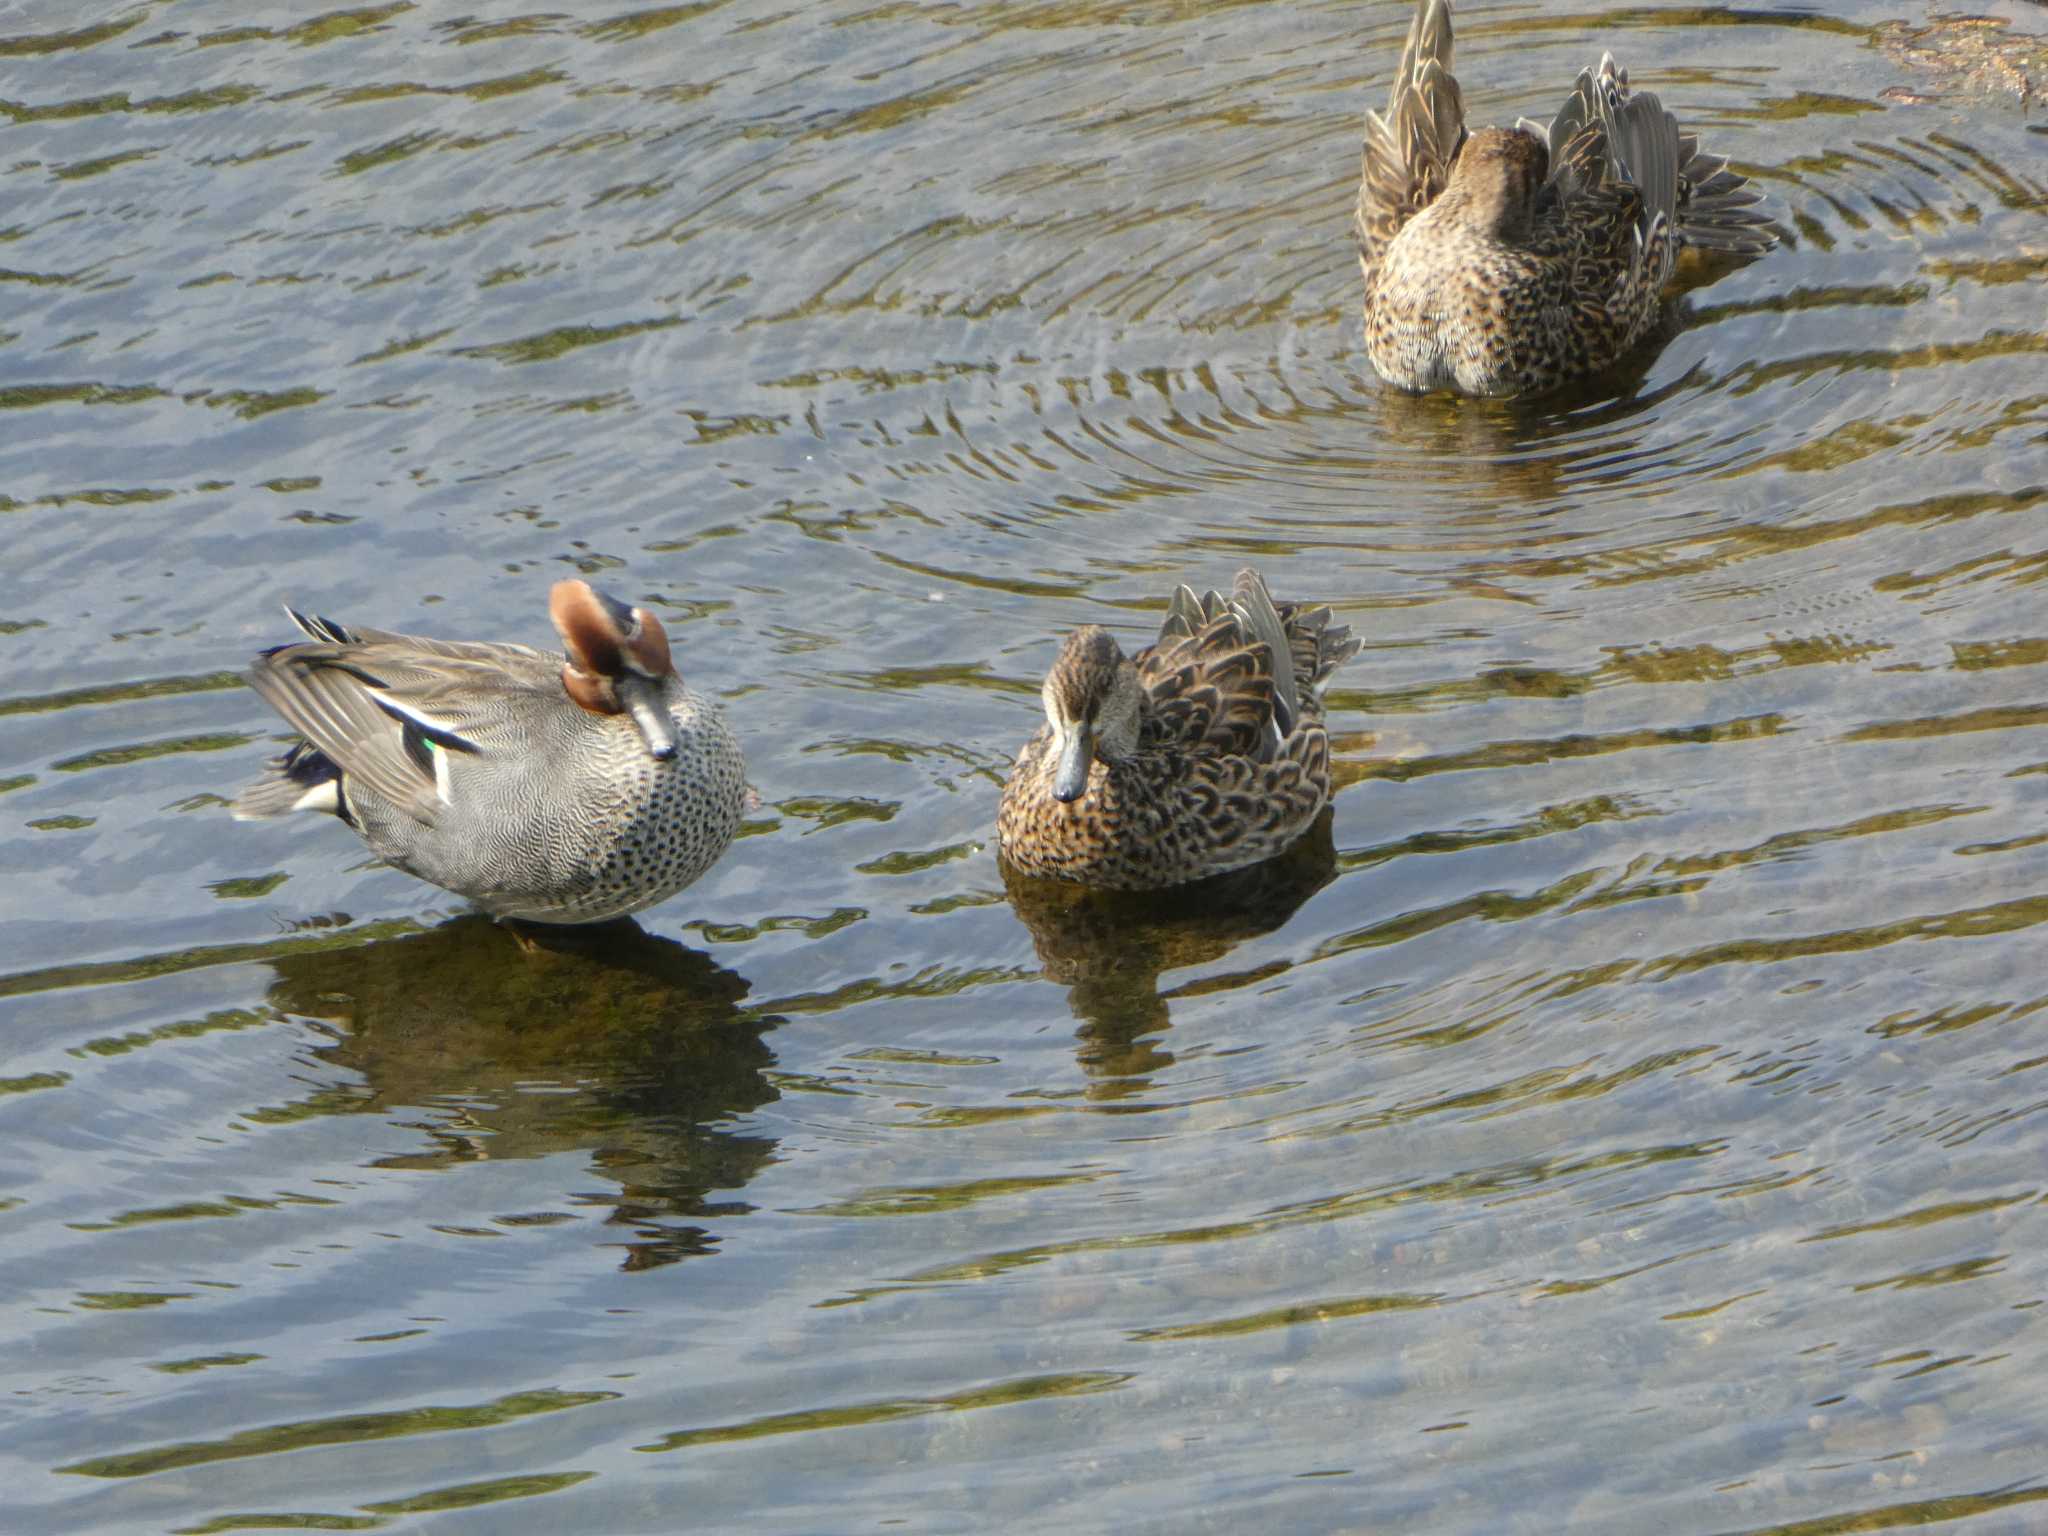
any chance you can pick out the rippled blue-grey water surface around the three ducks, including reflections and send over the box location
[0,0,2048,1536]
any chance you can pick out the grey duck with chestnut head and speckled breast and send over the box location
[229,580,748,924]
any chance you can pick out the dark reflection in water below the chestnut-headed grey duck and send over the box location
[270,918,780,1270]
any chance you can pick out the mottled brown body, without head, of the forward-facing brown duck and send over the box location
[997,571,1358,889]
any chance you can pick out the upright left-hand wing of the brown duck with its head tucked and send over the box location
[1352,0,1464,279]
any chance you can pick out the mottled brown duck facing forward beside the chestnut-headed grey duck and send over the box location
[997,569,1360,891]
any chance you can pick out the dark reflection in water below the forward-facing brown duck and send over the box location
[1001,807,1337,1098]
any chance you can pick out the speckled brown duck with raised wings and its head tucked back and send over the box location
[1354,0,1776,395]
